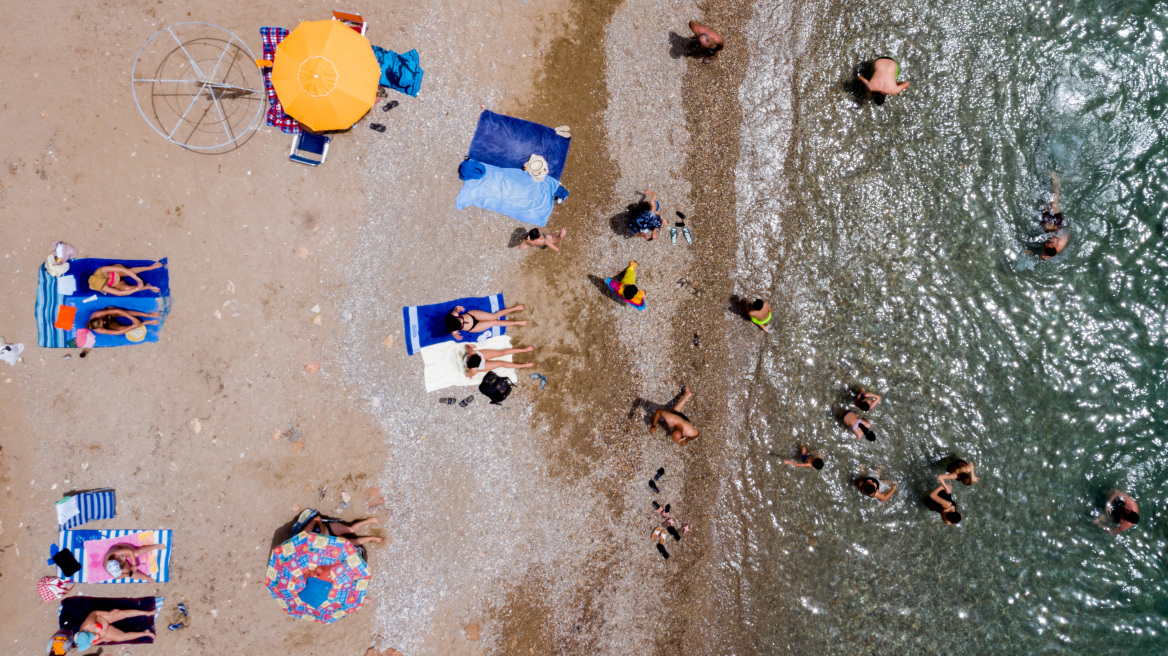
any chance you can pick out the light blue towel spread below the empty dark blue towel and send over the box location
[454,163,559,225]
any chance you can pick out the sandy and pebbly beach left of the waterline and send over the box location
[0,0,766,656]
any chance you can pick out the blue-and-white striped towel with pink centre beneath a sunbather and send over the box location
[57,529,173,584]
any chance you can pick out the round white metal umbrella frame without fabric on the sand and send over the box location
[130,21,267,152]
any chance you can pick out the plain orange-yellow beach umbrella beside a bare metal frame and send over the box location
[272,21,381,132]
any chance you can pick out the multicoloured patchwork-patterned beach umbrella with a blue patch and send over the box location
[267,525,370,624]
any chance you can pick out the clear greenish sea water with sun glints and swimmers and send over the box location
[722,0,1168,654]
